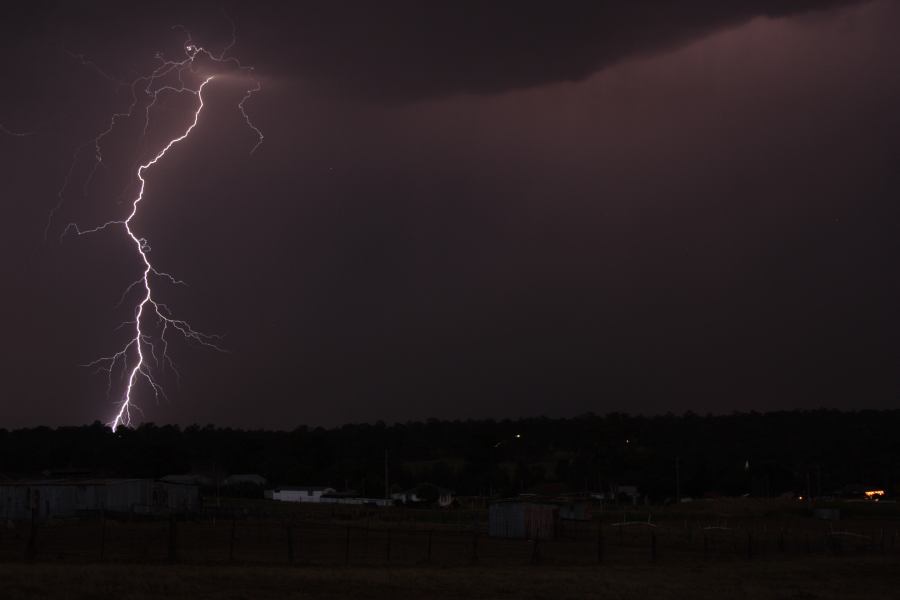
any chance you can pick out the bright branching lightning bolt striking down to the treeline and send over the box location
[52,23,264,431]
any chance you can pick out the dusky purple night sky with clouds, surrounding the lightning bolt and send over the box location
[0,0,900,428]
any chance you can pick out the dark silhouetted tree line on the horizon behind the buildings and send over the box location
[0,410,900,501]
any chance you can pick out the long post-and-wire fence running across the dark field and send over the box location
[0,510,900,566]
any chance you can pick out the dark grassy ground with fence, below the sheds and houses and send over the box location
[0,500,900,600]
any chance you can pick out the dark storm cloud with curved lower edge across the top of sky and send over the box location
[2,0,862,101]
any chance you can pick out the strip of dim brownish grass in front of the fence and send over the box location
[0,558,900,600]
